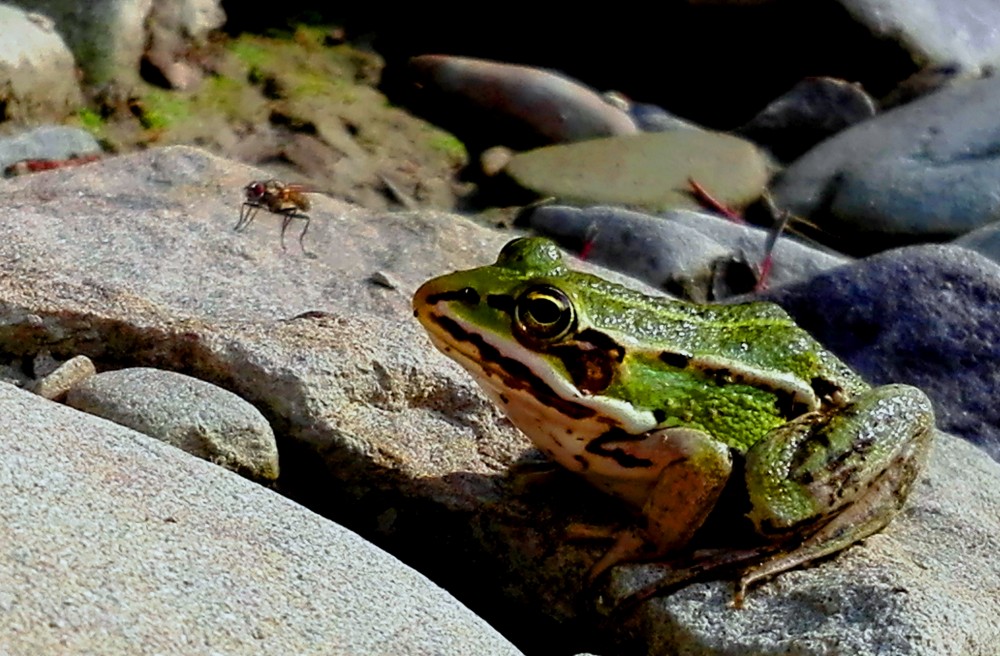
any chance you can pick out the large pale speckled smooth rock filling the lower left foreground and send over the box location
[0,384,519,655]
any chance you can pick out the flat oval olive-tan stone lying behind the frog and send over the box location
[506,130,769,212]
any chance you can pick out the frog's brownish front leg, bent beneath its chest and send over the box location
[590,428,733,580]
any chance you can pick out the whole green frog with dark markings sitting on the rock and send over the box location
[413,237,934,606]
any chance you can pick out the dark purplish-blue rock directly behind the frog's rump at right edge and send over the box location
[765,245,1000,461]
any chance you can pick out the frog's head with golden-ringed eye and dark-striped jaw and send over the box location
[413,237,656,442]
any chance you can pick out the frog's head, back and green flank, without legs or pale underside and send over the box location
[415,238,867,450]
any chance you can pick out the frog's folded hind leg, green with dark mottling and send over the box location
[737,385,934,602]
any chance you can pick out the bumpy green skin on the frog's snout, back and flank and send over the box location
[418,239,867,451]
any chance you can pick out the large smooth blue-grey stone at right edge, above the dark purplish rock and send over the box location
[773,77,1000,240]
